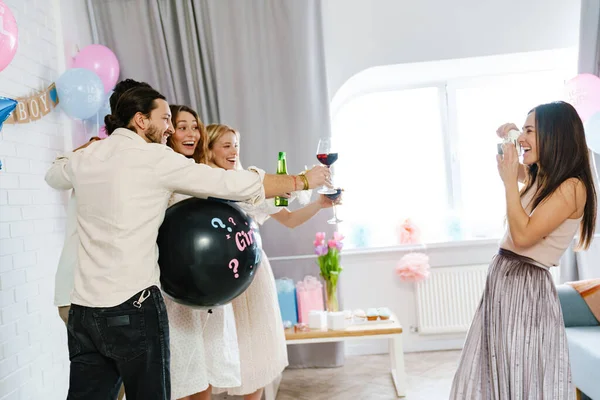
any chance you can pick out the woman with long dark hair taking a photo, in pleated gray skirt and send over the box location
[450,102,596,400]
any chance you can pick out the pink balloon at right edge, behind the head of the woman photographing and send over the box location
[565,74,600,121]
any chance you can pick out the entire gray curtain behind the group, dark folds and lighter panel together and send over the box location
[92,0,344,367]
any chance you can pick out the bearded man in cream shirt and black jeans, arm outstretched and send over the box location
[46,83,330,400]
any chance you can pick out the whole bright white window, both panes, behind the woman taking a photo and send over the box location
[332,52,576,248]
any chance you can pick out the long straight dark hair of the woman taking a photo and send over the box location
[521,101,596,249]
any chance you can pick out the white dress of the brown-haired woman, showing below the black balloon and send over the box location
[164,194,241,399]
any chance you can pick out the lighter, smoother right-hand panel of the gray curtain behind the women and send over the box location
[199,0,344,367]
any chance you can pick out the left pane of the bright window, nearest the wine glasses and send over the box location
[333,87,448,247]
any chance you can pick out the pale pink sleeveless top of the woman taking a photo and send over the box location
[500,185,583,267]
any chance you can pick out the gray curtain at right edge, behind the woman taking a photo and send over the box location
[560,0,600,283]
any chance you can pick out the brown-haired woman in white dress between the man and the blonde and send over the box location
[165,105,241,400]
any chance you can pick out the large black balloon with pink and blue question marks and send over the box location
[158,198,261,308]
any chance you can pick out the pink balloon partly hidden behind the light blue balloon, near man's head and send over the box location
[73,44,119,93]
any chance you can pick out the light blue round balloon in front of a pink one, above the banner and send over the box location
[56,68,104,119]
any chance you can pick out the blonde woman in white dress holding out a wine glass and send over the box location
[207,124,340,400]
